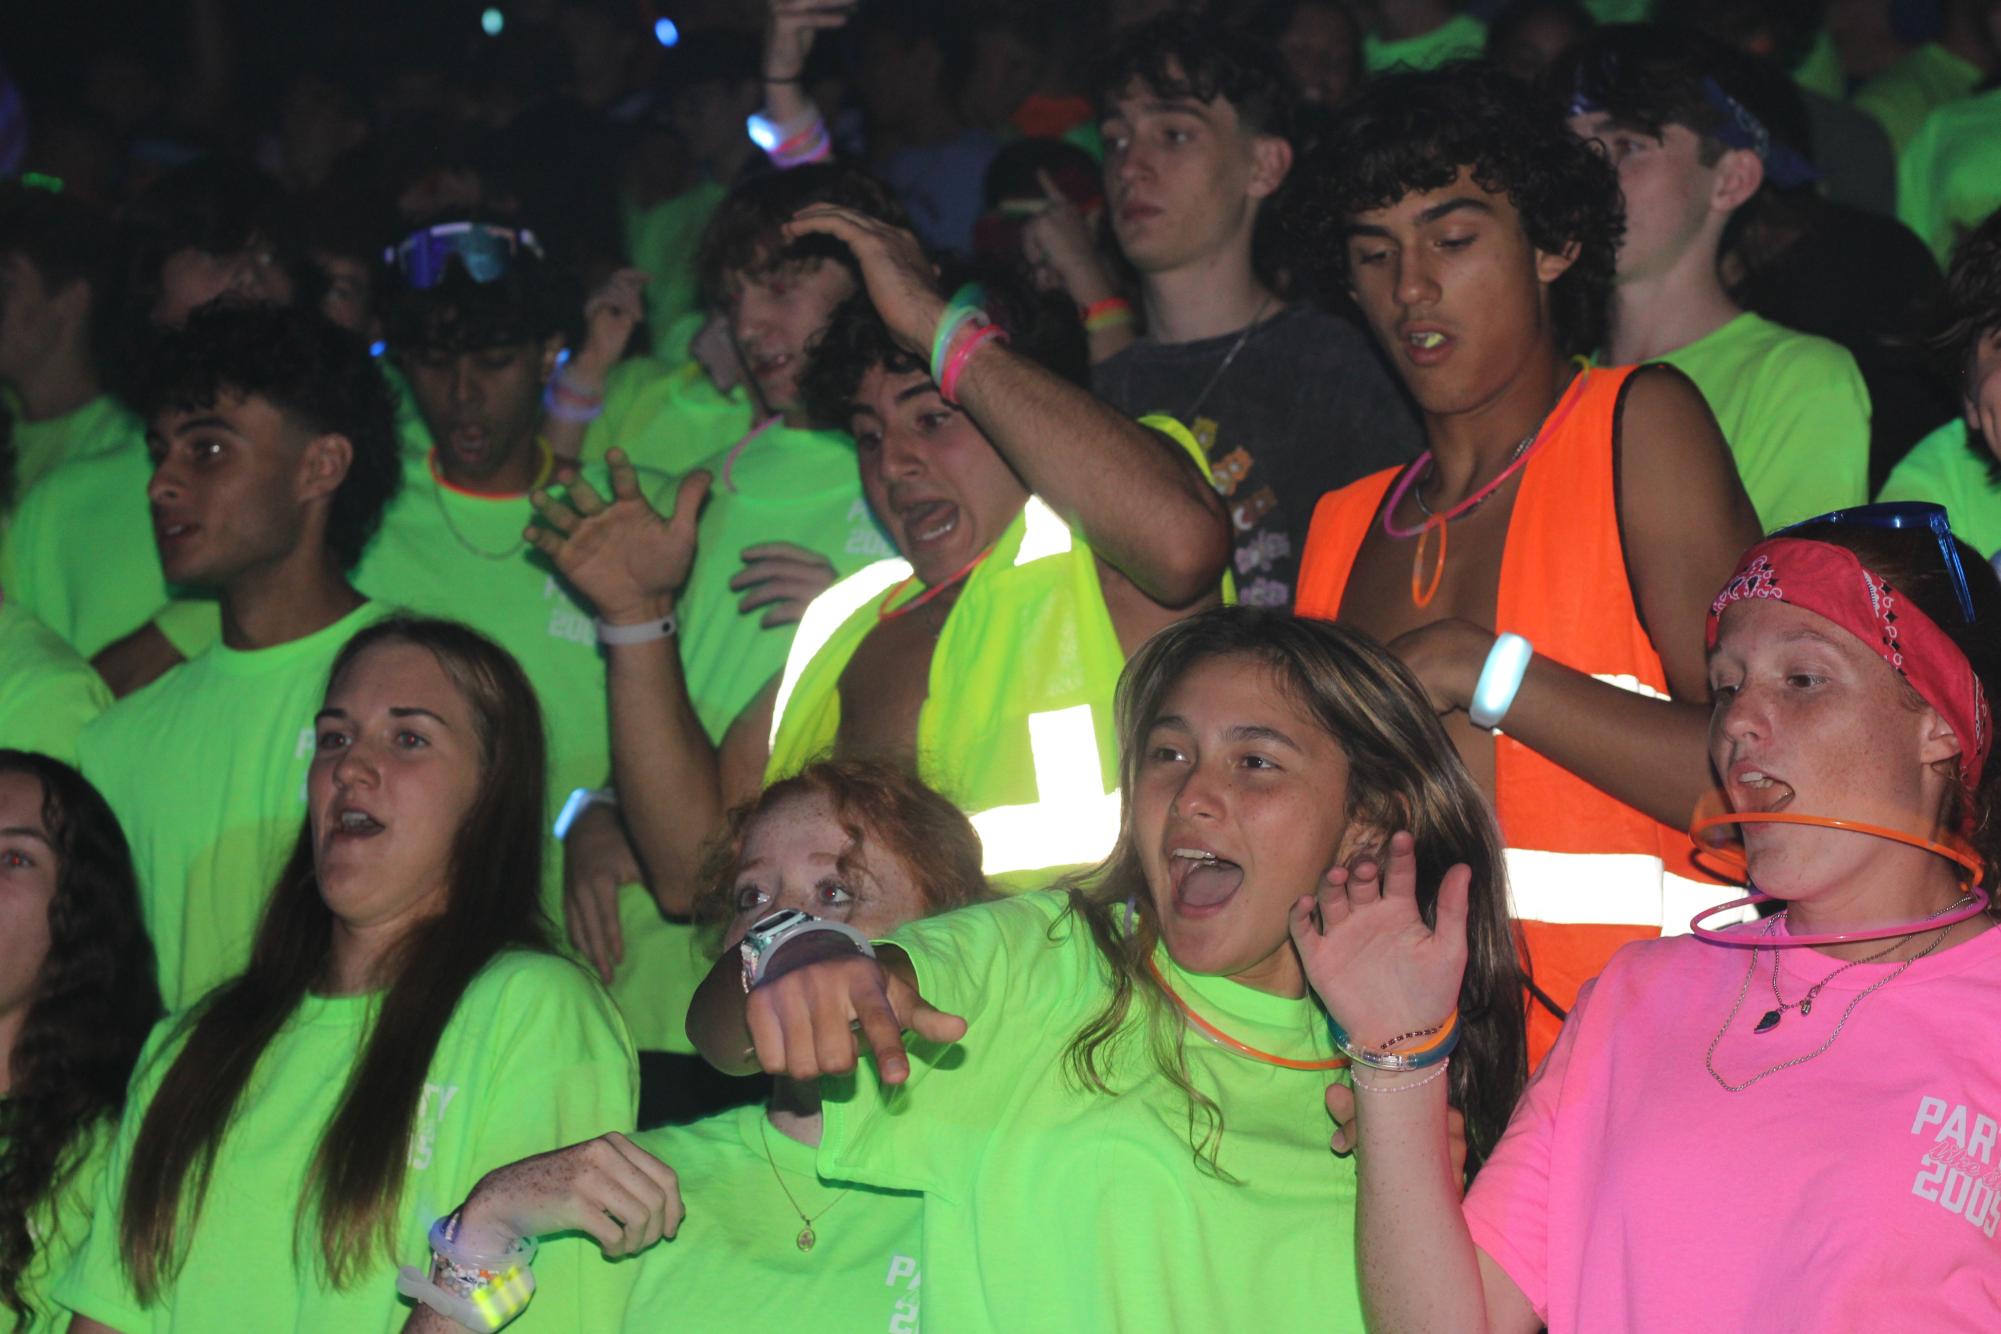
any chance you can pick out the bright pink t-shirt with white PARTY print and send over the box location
[1465,922,2001,1334]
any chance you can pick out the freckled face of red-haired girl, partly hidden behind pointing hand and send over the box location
[726,794,928,948]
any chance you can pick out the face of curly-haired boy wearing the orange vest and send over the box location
[1347,170,1569,416]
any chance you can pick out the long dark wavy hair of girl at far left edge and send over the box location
[0,750,160,1328]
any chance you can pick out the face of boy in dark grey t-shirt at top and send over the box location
[1101,84,1291,274]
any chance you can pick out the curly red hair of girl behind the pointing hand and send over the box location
[694,760,994,954]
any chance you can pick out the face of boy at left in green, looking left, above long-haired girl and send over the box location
[146,392,330,588]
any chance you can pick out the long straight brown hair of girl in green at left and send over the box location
[120,616,554,1304]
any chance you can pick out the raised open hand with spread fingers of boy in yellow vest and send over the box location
[526,450,708,624]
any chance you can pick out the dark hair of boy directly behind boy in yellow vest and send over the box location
[694,162,910,310]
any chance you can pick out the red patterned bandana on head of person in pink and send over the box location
[1709,538,1993,788]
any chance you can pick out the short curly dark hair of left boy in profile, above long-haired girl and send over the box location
[132,306,402,570]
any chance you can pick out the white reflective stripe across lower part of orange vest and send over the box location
[1507,848,1757,936]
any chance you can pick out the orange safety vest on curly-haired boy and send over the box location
[1297,366,1723,1066]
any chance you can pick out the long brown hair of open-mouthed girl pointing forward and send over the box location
[1069,606,1529,1176]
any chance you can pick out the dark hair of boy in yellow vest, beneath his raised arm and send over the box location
[798,262,1091,430]
